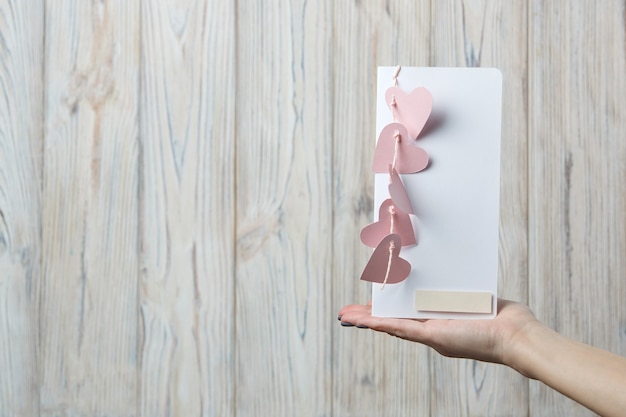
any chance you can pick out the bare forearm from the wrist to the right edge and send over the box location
[505,325,626,417]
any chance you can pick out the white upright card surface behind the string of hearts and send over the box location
[372,67,502,319]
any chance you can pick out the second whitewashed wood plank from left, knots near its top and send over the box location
[40,0,139,416]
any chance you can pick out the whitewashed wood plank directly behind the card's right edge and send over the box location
[431,0,529,416]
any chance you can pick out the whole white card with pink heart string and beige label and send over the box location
[361,67,502,319]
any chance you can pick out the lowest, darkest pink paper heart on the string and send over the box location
[361,234,411,284]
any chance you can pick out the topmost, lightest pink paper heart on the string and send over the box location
[385,87,433,139]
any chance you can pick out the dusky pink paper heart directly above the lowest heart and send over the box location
[361,198,417,248]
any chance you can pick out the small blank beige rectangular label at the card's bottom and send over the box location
[415,290,492,314]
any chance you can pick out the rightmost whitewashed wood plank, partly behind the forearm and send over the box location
[529,0,626,416]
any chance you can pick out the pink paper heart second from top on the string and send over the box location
[373,123,428,174]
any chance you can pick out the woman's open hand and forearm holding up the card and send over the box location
[339,300,626,417]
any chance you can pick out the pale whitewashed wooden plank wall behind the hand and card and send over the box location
[0,0,626,417]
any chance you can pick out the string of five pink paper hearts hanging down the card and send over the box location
[361,67,433,290]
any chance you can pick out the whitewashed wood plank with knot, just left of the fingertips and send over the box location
[236,0,335,417]
